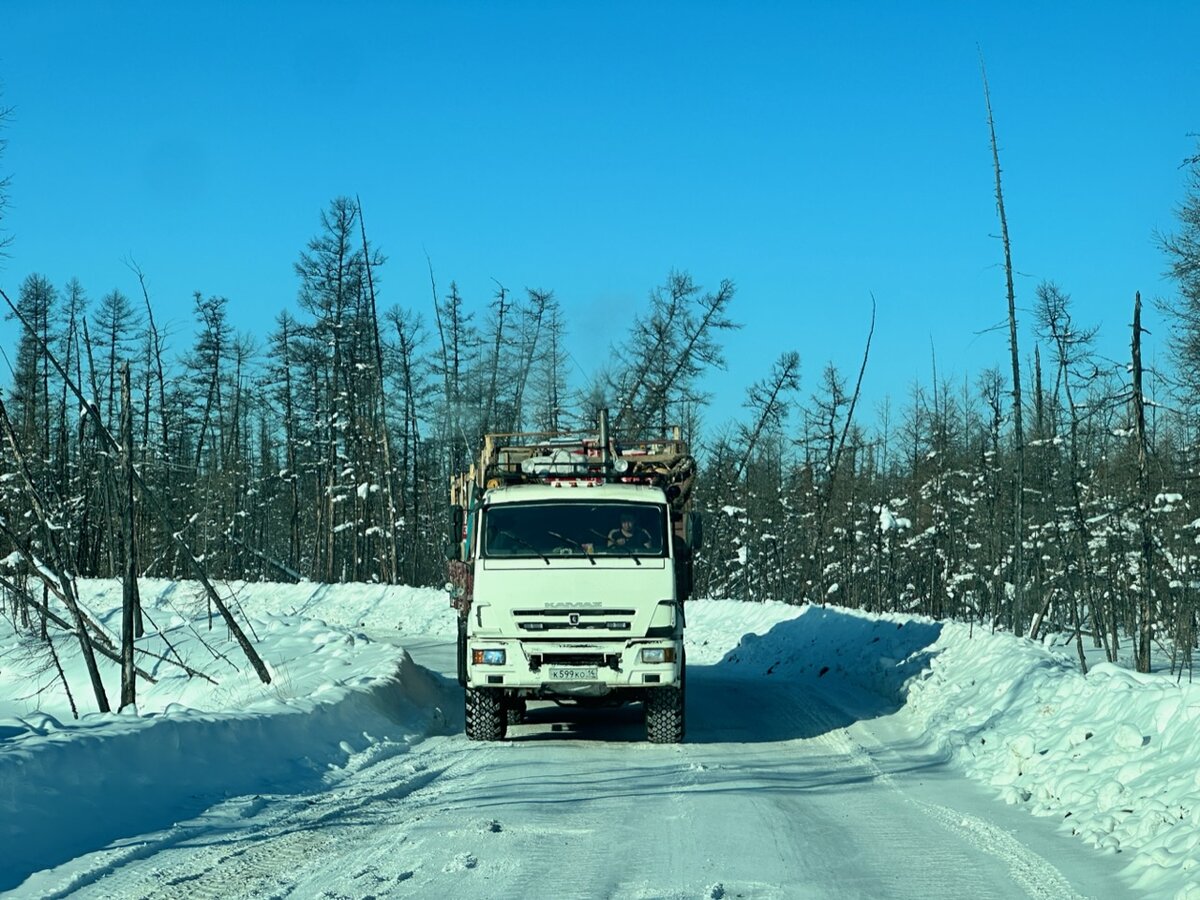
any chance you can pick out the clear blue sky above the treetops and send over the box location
[0,0,1200,434]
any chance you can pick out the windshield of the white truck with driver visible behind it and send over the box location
[484,502,667,558]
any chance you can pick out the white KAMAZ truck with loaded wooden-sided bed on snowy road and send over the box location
[446,414,701,743]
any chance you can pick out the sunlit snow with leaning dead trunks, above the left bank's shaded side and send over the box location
[0,578,454,736]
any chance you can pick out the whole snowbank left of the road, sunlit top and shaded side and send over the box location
[0,580,454,892]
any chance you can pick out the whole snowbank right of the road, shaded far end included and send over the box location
[710,605,1200,899]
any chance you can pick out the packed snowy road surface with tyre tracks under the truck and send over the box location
[14,637,1130,900]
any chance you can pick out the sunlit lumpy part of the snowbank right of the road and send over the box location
[907,624,1200,896]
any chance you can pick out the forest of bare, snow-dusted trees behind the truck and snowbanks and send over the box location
[0,77,1200,705]
